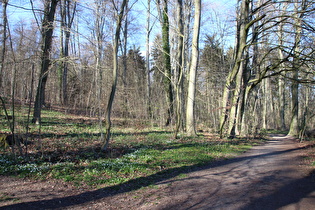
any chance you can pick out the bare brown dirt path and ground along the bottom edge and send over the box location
[0,135,315,210]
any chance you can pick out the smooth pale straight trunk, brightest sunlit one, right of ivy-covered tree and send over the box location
[186,0,201,136]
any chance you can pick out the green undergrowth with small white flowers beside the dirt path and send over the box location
[0,108,260,188]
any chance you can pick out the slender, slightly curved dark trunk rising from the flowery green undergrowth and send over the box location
[102,0,128,150]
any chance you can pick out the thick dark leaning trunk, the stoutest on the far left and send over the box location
[32,0,58,123]
